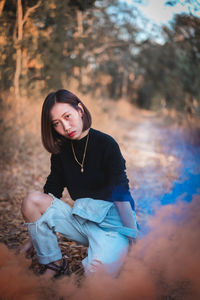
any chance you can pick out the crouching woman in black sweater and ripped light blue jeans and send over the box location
[22,89,137,276]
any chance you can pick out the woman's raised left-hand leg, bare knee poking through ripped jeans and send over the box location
[22,192,88,272]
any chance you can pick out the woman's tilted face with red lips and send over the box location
[50,103,86,140]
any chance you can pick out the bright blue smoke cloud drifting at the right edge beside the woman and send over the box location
[132,129,200,232]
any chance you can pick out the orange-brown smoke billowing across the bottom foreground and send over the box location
[0,197,200,300]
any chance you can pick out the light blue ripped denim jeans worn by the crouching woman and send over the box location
[27,194,137,275]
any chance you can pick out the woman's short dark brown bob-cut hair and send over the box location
[41,89,92,154]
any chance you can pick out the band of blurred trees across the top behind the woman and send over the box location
[0,0,200,114]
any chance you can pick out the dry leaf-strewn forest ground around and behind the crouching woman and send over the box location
[0,101,200,298]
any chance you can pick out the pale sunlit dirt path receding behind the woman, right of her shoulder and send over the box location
[112,111,182,220]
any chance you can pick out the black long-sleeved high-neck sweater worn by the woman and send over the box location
[44,128,134,209]
